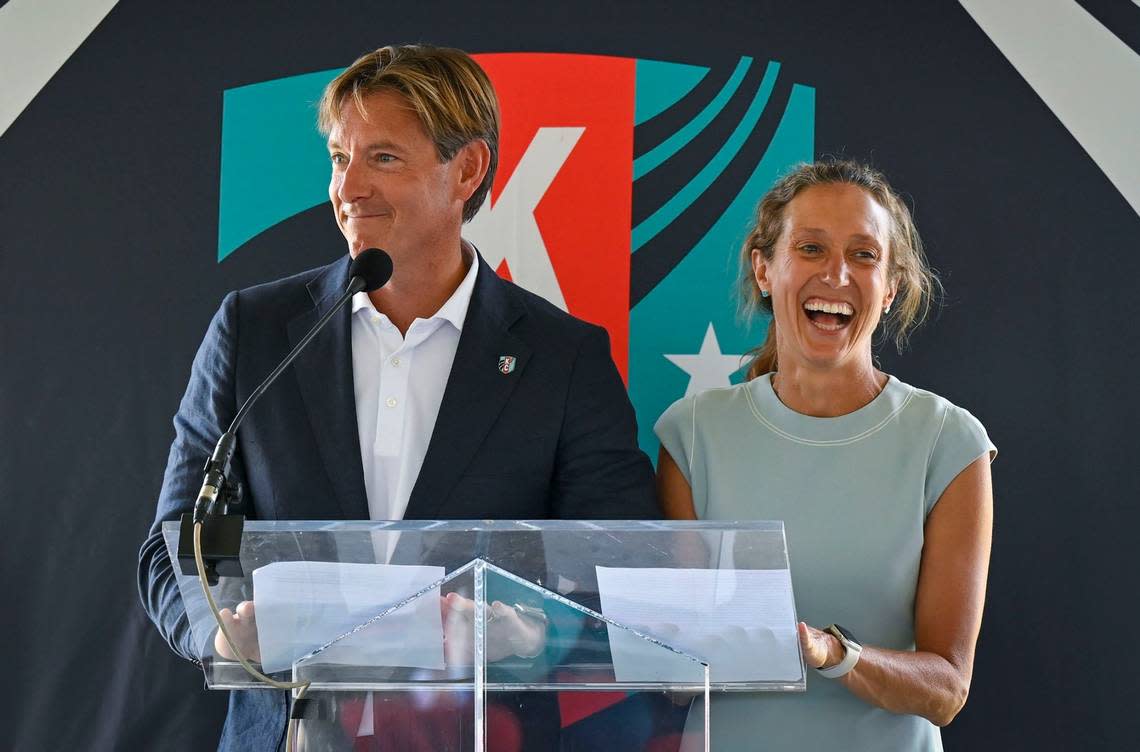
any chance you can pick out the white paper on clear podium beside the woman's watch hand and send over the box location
[597,566,803,682]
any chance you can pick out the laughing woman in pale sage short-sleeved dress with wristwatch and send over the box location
[657,162,996,751]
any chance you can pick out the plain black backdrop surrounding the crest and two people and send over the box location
[0,0,1140,750]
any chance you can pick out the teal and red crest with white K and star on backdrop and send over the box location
[218,54,815,458]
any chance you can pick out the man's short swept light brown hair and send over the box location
[317,44,499,222]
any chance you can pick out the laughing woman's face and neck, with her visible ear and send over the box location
[752,183,896,369]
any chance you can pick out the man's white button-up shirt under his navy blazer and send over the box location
[352,244,479,520]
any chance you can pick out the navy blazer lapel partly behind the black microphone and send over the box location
[287,256,368,520]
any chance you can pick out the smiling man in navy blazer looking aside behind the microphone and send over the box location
[139,47,658,750]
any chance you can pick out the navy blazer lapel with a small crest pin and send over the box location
[404,256,531,520]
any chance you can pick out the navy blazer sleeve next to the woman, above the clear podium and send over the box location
[553,327,661,520]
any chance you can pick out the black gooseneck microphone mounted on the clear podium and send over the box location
[178,248,392,585]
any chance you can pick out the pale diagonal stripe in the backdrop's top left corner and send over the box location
[0,0,119,136]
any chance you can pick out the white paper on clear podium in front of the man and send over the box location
[253,562,445,673]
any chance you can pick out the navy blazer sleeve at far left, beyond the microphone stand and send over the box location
[138,293,244,660]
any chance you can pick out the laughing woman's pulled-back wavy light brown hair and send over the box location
[739,160,942,378]
